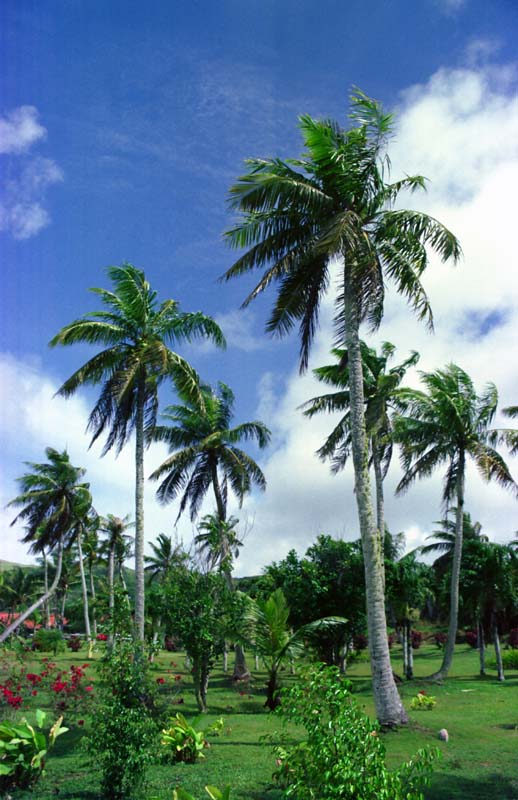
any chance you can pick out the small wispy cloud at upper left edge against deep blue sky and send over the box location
[0,106,63,240]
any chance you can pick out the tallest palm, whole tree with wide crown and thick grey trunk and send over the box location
[221,91,460,725]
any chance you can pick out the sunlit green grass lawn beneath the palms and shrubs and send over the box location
[4,645,518,800]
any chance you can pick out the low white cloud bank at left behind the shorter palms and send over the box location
[0,354,210,563]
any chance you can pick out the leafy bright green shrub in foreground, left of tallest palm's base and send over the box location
[275,665,438,800]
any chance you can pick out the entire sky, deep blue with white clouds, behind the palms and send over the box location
[0,0,518,571]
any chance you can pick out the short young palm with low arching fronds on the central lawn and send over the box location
[241,589,346,711]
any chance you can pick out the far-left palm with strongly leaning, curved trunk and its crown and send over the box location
[0,447,91,644]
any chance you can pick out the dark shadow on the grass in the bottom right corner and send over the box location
[424,772,518,800]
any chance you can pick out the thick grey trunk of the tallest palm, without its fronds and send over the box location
[344,265,408,725]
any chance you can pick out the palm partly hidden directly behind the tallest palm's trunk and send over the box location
[302,342,419,549]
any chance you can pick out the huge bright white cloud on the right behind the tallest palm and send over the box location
[240,61,518,573]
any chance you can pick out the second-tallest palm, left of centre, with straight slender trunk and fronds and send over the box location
[50,264,224,639]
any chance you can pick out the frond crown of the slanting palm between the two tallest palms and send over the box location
[151,383,270,521]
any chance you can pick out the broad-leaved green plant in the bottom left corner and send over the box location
[0,709,68,796]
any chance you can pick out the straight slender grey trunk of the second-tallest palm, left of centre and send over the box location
[135,377,145,641]
